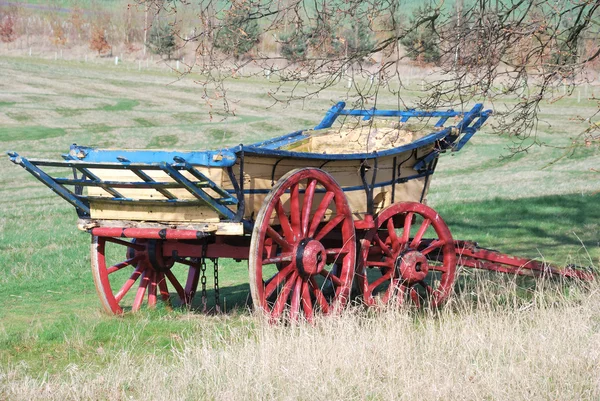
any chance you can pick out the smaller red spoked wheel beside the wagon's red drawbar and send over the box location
[357,202,456,307]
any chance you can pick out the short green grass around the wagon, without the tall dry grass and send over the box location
[0,53,600,390]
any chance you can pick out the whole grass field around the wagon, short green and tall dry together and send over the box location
[0,58,600,400]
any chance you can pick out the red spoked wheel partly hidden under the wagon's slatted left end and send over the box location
[91,236,200,314]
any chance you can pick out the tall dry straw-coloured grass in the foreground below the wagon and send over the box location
[0,277,600,400]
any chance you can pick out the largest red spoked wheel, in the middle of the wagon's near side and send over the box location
[249,168,356,321]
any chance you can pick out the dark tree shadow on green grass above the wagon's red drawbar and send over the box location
[436,194,600,265]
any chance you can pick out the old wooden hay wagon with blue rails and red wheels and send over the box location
[9,102,591,320]
